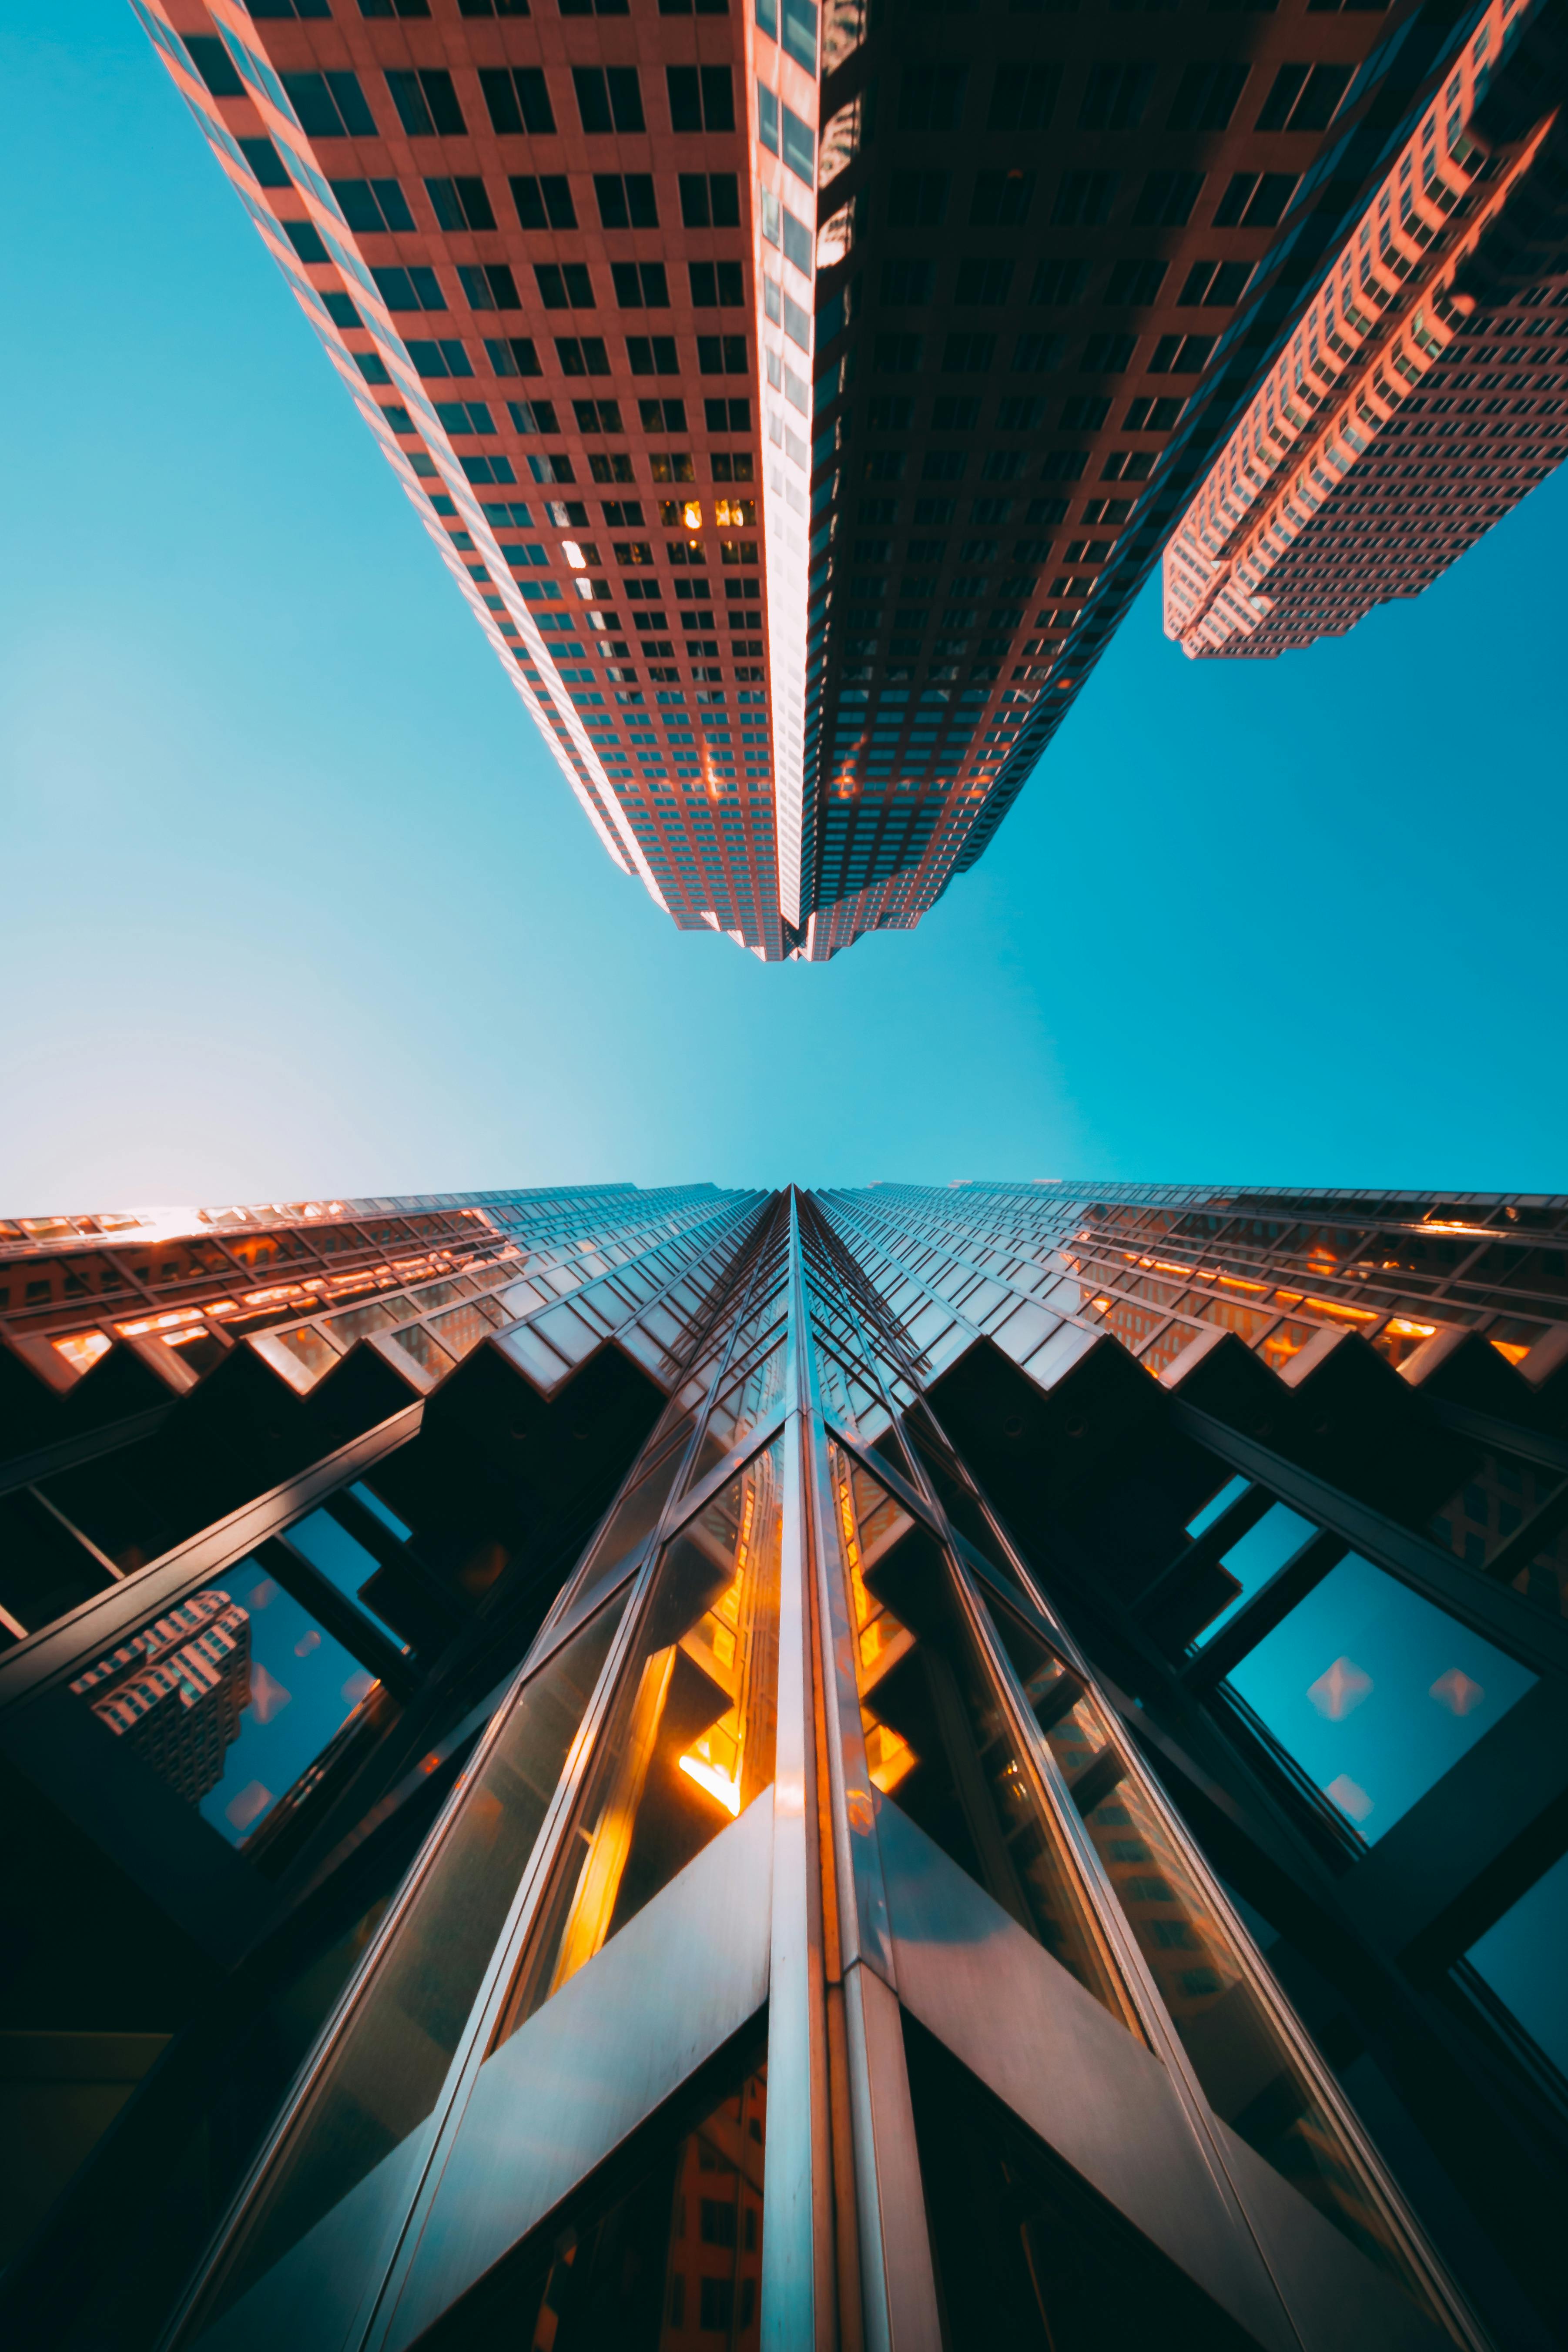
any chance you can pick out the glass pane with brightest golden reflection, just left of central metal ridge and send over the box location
[501,1447,781,2034]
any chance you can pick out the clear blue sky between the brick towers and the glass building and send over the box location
[0,18,1568,1211]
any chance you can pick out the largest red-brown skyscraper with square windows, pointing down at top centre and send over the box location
[134,0,1551,957]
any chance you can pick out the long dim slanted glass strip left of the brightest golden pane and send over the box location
[183,1604,620,2347]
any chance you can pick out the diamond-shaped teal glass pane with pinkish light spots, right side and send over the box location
[1230,1552,1535,1844]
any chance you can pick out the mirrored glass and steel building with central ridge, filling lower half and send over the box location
[0,1183,1568,2352]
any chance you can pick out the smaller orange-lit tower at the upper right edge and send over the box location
[1164,0,1568,659]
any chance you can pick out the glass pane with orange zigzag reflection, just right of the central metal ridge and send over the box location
[830,1447,1131,2023]
